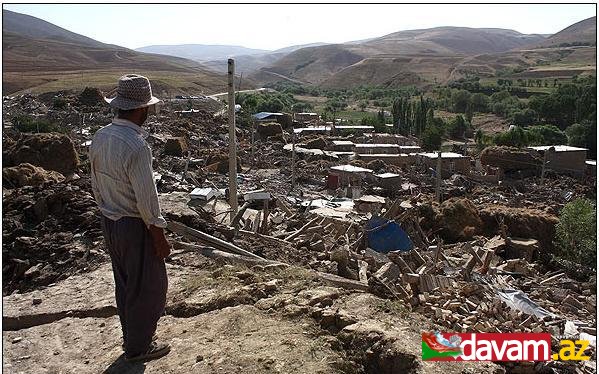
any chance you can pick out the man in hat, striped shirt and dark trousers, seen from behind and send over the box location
[89,74,171,361]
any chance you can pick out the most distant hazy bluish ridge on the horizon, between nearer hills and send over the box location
[136,44,269,62]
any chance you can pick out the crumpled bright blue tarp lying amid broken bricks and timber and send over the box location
[364,217,414,253]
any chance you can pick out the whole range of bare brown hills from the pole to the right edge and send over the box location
[251,17,596,88]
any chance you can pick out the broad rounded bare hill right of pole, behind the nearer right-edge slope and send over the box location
[254,27,544,87]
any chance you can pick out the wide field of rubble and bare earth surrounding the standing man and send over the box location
[2,88,597,373]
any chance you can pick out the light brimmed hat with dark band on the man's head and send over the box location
[104,74,160,110]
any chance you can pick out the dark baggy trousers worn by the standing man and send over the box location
[102,217,168,356]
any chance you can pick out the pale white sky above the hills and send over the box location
[4,4,596,50]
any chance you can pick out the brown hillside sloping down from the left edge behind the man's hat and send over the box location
[2,11,226,94]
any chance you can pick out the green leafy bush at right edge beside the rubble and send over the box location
[555,199,597,268]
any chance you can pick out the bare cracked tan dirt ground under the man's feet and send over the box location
[3,262,504,373]
